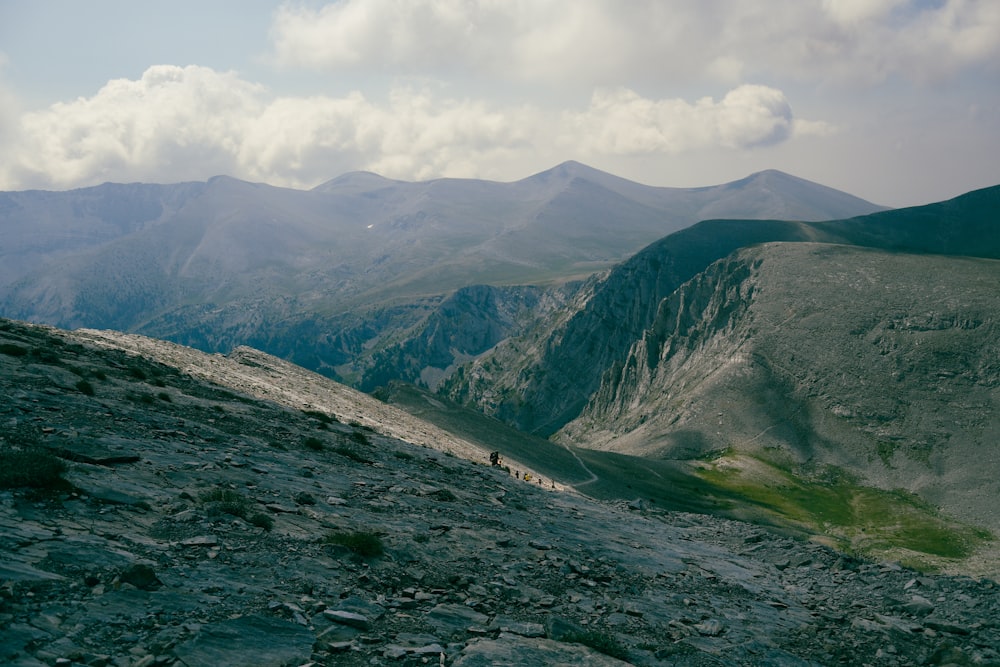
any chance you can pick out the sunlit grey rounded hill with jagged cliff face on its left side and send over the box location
[560,243,1000,527]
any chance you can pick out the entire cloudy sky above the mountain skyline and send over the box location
[0,0,1000,206]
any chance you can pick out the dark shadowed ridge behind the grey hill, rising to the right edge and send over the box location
[446,187,1000,435]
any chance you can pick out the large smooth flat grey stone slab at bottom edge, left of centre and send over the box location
[174,616,315,667]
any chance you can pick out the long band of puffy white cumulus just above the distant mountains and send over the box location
[0,65,822,189]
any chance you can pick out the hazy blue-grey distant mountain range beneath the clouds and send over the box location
[0,162,880,388]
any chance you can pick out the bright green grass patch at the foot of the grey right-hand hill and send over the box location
[696,453,993,570]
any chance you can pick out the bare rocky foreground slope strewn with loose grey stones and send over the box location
[0,321,1000,667]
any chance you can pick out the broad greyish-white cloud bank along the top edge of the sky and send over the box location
[271,0,1000,86]
